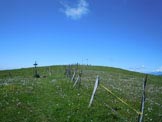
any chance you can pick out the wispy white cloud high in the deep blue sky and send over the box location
[63,0,89,20]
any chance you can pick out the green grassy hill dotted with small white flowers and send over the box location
[0,66,162,122]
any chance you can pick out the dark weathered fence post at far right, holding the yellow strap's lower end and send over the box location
[138,75,147,122]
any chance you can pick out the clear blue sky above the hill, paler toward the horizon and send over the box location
[0,0,162,72]
